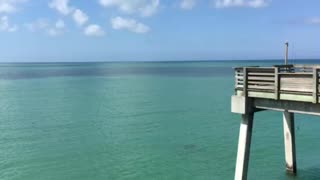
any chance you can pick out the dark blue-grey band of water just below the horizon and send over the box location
[0,66,233,79]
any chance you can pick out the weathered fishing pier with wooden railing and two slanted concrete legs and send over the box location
[231,64,320,180]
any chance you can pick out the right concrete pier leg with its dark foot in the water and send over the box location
[283,111,297,174]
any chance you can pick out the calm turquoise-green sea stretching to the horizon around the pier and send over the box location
[0,61,320,180]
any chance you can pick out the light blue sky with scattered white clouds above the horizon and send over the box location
[0,0,320,62]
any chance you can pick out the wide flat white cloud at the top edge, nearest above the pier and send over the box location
[214,0,271,8]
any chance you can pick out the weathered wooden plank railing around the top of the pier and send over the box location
[235,65,320,103]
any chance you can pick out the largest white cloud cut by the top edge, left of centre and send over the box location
[99,0,160,17]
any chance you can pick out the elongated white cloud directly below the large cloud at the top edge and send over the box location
[111,17,150,33]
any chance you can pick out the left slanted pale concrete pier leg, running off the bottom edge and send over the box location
[234,113,254,180]
